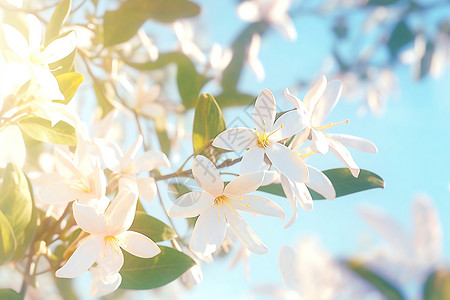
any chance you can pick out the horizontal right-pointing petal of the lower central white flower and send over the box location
[231,195,286,220]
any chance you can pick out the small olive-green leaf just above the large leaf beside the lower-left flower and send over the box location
[130,211,177,243]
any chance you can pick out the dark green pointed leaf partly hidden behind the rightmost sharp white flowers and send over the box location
[258,168,384,200]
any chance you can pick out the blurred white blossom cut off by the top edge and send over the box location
[237,0,297,41]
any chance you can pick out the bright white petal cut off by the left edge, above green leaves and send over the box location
[0,125,27,168]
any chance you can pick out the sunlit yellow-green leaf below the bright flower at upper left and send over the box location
[19,117,77,146]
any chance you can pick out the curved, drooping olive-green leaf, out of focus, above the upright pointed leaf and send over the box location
[126,52,210,109]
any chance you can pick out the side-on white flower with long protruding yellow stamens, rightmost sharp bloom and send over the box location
[285,75,378,177]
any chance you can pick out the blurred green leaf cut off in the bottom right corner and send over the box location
[423,270,450,300]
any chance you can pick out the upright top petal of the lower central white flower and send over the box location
[192,155,223,197]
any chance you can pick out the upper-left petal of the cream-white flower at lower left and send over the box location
[72,201,107,234]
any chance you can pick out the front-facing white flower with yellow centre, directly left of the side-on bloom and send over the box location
[212,89,308,182]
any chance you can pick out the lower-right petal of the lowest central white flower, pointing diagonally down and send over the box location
[224,207,269,254]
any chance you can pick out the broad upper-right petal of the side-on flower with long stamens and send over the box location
[311,80,342,125]
